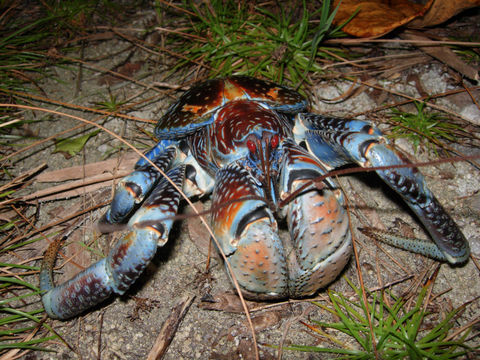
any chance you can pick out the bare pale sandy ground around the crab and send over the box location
[4,6,480,359]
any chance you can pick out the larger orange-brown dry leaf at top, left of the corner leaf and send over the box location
[334,0,433,38]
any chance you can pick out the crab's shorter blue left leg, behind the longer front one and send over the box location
[98,141,179,233]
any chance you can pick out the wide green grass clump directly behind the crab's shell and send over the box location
[159,0,348,86]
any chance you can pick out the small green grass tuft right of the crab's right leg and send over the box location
[391,101,462,152]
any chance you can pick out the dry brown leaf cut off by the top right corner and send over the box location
[408,0,480,28]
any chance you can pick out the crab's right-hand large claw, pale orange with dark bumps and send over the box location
[280,141,352,297]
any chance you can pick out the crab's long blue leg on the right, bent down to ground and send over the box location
[295,114,470,264]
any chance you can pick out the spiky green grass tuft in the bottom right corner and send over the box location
[287,279,473,360]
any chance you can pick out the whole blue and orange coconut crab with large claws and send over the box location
[40,76,469,319]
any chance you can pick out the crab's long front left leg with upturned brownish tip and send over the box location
[40,165,185,319]
